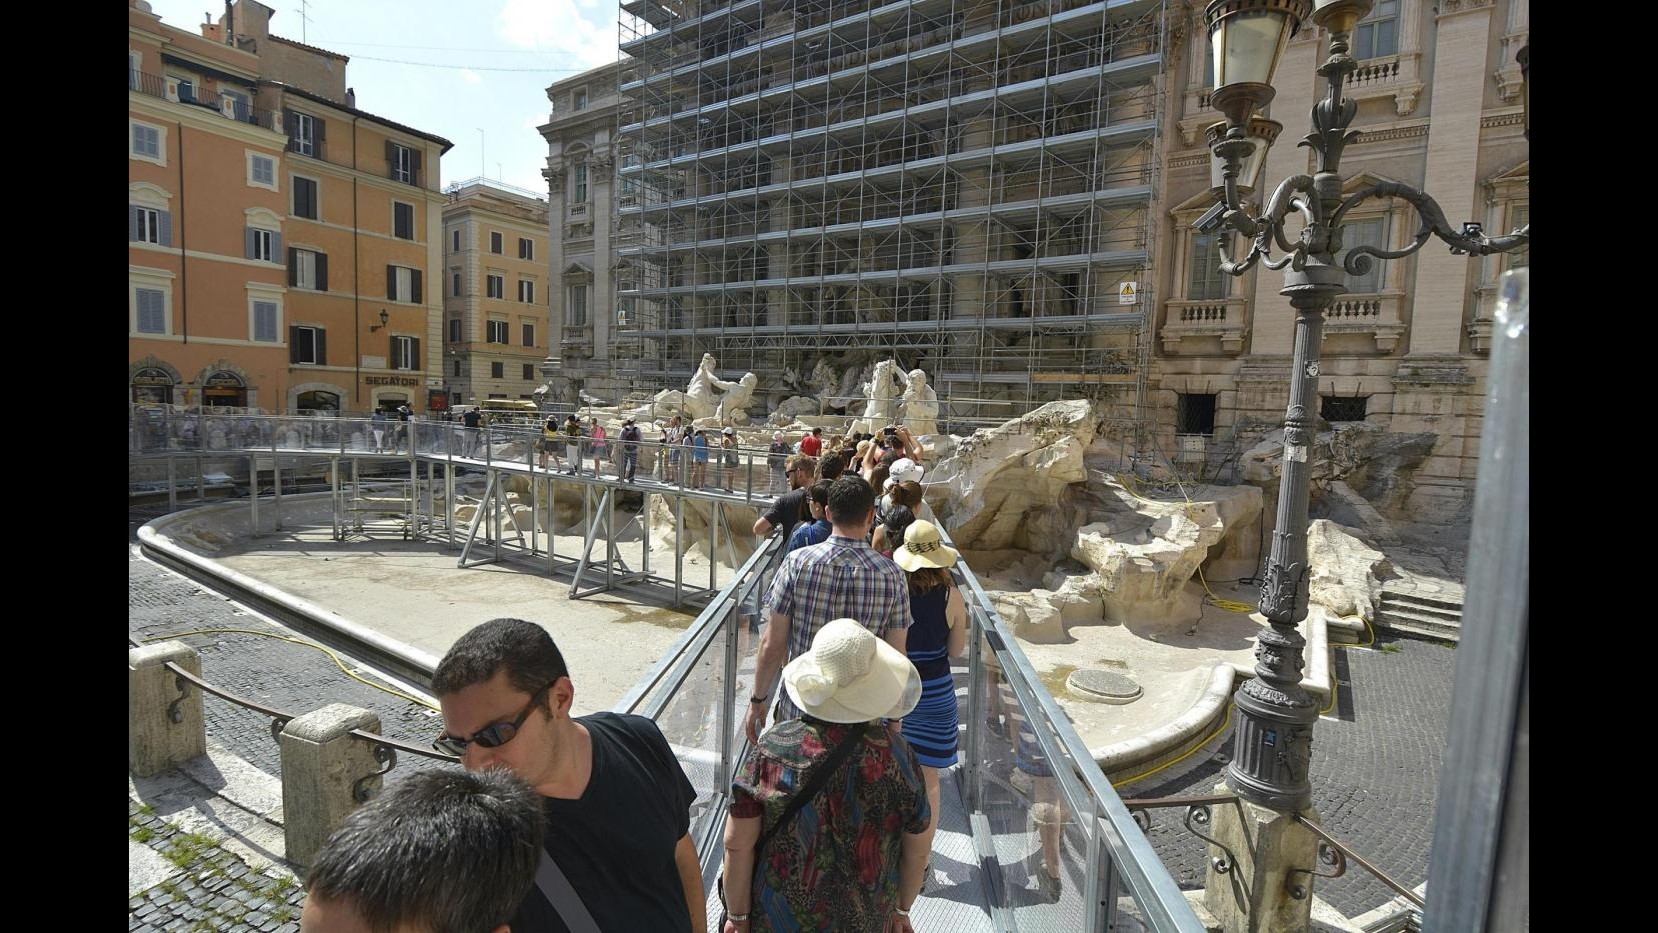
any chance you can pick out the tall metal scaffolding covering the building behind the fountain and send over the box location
[612,0,1164,418]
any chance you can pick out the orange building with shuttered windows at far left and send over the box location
[128,0,451,411]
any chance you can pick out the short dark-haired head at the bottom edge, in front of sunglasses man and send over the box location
[300,769,545,933]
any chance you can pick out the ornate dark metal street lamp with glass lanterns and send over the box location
[1199,0,1530,812]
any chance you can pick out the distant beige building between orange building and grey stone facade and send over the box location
[443,177,549,408]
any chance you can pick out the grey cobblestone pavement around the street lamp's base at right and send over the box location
[1124,635,1456,916]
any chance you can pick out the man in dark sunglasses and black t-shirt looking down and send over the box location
[431,618,705,933]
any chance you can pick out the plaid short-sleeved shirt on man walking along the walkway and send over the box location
[766,535,910,723]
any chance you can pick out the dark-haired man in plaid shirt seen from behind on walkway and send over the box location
[743,476,910,742]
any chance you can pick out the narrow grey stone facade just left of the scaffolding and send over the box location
[537,65,638,403]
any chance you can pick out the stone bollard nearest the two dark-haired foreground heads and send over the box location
[277,703,381,865]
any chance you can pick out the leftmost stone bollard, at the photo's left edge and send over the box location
[126,641,207,777]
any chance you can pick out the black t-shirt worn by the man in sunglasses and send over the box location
[511,713,696,933]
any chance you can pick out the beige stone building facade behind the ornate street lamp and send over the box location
[1147,0,1530,524]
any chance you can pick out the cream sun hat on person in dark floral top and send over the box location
[783,618,922,723]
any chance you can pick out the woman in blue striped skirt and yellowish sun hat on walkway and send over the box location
[892,520,967,852]
